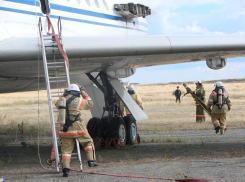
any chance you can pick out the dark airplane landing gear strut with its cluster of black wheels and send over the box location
[86,72,137,145]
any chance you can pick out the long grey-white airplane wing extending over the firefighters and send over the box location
[0,36,245,93]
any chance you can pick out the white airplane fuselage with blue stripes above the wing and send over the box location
[0,0,148,41]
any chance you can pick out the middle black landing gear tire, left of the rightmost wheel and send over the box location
[107,117,127,145]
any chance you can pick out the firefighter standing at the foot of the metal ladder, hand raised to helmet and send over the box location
[55,84,99,177]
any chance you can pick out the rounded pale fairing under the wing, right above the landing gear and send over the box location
[106,68,136,78]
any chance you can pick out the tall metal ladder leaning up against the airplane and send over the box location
[38,15,82,172]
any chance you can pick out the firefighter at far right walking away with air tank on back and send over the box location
[207,82,231,135]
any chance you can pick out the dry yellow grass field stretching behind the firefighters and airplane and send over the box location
[0,80,245,137]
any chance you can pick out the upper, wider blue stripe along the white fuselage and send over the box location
[5,0,147,27]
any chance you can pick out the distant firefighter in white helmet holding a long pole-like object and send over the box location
[193,80,206,123]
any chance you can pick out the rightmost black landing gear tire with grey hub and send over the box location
[123,116,137,145]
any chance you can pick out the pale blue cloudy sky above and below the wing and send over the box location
[123,0,245,84]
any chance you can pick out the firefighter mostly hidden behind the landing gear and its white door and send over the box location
[120,84,144,115]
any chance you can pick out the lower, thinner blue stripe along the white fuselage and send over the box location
[0,7,147,32]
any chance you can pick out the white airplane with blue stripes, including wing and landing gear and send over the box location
[0,0,245,145]
